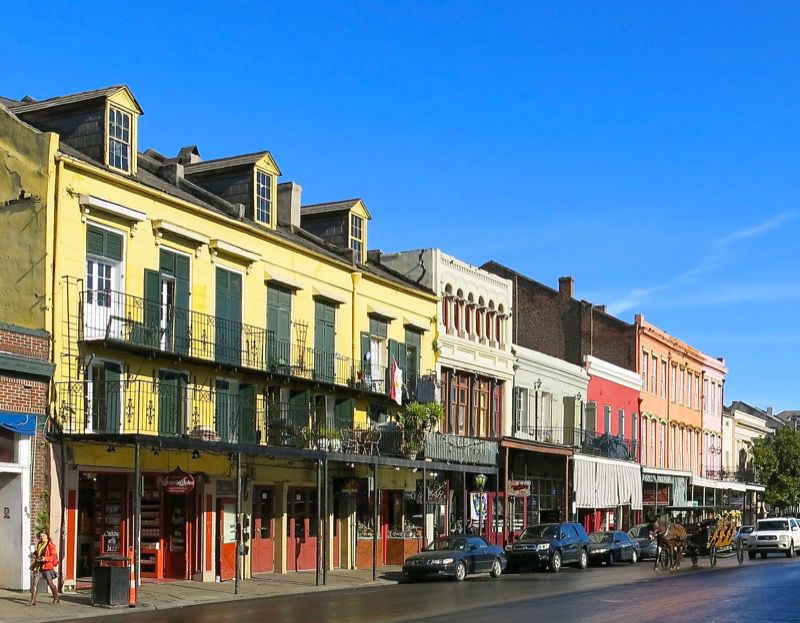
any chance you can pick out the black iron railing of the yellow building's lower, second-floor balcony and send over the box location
[55,375,488,465]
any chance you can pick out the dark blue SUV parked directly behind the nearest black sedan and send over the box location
[506,521,589,572]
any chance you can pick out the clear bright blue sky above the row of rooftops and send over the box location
[0,1,800,410]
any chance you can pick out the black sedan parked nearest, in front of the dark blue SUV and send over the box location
[403,535,506,582]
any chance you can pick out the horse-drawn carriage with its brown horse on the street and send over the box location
[656,511,746,569]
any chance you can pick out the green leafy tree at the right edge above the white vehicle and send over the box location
[753,428,800,509]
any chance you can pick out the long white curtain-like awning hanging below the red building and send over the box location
[572,454,642,510]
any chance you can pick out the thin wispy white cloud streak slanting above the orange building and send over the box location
[608,210,800,315]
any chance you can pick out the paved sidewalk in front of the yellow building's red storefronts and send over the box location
[0,567,403,623]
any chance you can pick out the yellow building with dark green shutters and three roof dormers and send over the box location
[0,86,496,585]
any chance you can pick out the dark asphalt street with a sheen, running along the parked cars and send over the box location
[53,557,800,623]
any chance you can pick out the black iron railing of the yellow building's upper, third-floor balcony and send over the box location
[80,290,368,394]
